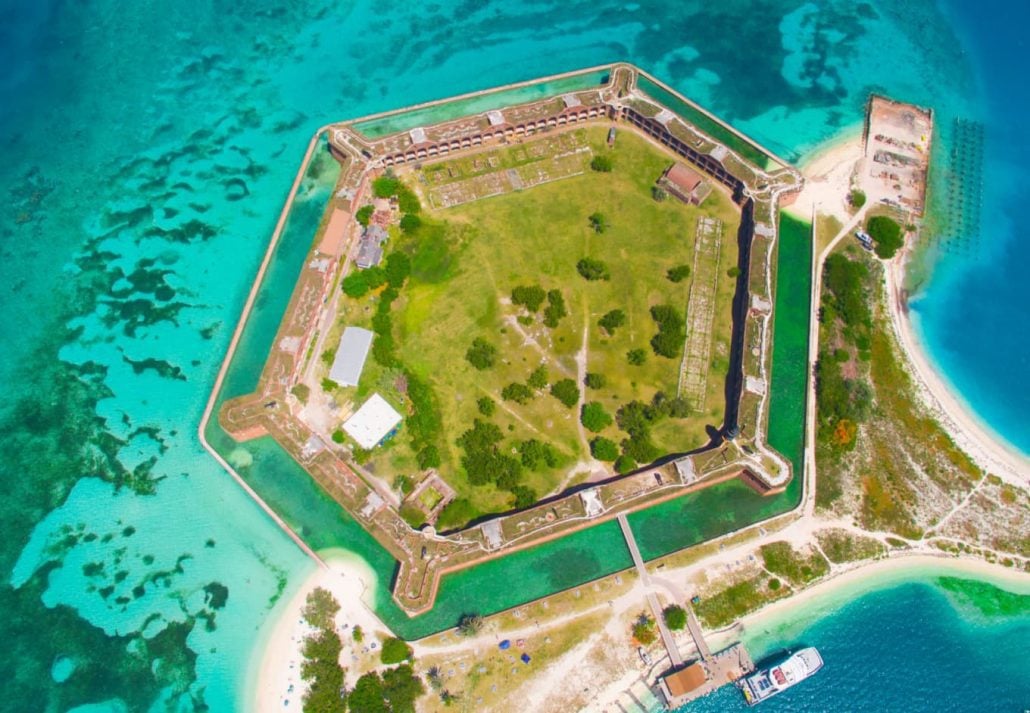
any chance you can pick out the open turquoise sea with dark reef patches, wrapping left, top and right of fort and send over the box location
[0,0,1030,711]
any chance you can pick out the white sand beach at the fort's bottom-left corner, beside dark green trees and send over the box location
[246,550,389,713]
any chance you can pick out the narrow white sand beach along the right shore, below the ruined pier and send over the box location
[886,250,1030,487]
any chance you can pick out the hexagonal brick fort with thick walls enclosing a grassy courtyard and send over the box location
[218,64,801,614]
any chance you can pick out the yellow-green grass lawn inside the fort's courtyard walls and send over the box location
[333,127,740,512]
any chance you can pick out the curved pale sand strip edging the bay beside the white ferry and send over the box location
[710,552,1030,655]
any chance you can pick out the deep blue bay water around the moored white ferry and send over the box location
[680,578,1030,713]
